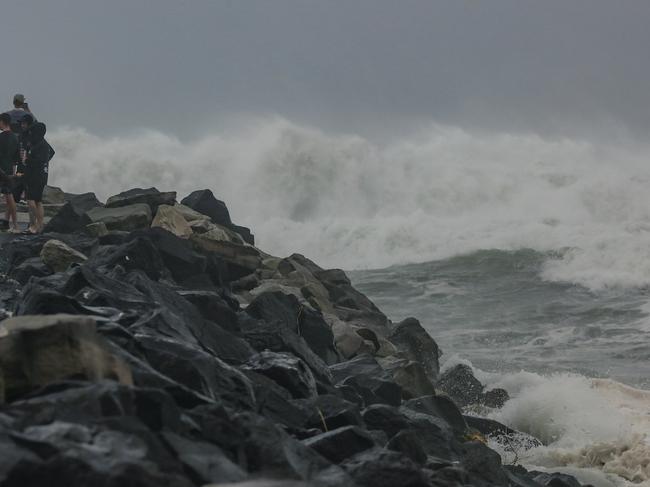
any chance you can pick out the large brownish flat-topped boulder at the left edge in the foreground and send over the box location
[0,315,132,400]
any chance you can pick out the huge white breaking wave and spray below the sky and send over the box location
[50,118,650,288]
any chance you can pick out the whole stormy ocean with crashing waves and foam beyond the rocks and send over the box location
[49,117,650,486]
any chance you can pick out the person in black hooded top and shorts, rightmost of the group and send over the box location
[25,122,54,234]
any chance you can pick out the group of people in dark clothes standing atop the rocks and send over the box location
[0,94,54,233]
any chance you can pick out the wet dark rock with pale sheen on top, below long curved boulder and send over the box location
[243,351,317,399]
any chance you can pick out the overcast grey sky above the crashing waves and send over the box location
[1,0,650,139]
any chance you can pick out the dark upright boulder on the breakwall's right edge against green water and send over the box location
[389,318,440,381]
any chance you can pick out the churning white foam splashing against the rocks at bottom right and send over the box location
[443,356,650,487]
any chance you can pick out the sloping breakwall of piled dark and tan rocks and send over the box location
[0,188,574,487]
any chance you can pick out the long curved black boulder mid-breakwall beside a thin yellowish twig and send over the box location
[246,292,339,365]
